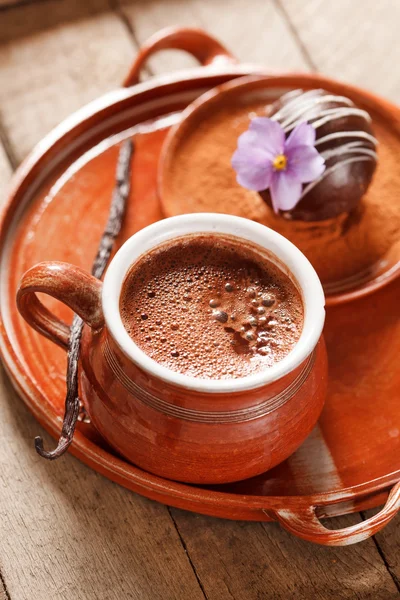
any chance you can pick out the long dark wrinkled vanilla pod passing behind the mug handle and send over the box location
[35,140,134,460]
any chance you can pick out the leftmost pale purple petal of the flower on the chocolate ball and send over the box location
[232,147,273,192]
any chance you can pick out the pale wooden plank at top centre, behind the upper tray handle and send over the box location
[119,0,307,73]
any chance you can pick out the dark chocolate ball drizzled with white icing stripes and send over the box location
[260,90,378,221]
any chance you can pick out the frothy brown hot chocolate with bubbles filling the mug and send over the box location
[120,234,303,379]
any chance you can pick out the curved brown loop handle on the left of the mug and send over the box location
[17,262,104,349]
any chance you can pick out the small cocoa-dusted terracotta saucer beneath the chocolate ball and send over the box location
[159,73,400,305]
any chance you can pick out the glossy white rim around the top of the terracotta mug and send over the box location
[102,213,325,393]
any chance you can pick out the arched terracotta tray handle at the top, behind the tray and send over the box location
[123,27,237,87]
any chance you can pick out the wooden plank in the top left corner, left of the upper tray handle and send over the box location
[0,0,135,160]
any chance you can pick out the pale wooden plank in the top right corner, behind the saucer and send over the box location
[279,0,400,102]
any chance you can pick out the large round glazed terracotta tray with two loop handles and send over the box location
[0,30,400,545]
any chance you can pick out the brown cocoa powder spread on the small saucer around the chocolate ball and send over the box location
[162,102,400,283]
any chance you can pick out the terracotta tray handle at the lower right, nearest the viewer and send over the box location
[273,481,400,546]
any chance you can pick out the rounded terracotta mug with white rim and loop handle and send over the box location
[17,213,327,483]
